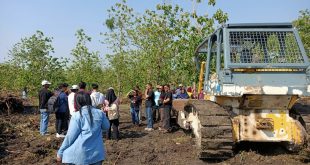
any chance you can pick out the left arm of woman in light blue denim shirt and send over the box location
[57,113,82,158]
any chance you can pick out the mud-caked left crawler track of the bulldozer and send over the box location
[187,100,234,159]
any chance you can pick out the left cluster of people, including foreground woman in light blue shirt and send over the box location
[39,80,119,165]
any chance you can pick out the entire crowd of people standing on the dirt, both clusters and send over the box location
[39,80,197,164]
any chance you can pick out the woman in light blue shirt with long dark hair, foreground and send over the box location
[57,92,109,165]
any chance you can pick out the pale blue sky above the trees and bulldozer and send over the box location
[0,0,310,62]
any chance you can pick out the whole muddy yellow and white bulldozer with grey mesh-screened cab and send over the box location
[173,23,310,159]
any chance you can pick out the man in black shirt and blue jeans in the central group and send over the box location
[144,83,155,131]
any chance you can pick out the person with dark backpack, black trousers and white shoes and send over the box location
[56,83,69,138]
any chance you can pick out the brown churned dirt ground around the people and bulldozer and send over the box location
[0,105,310,165]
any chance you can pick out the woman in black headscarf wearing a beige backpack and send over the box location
[105,88,119,140]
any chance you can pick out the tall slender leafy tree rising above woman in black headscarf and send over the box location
[102,0,134,96]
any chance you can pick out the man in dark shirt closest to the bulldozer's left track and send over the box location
[163,84,172,132]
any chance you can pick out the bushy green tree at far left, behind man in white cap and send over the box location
[9,31,66,94]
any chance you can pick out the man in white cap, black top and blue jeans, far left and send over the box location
[39,80,53,136]
